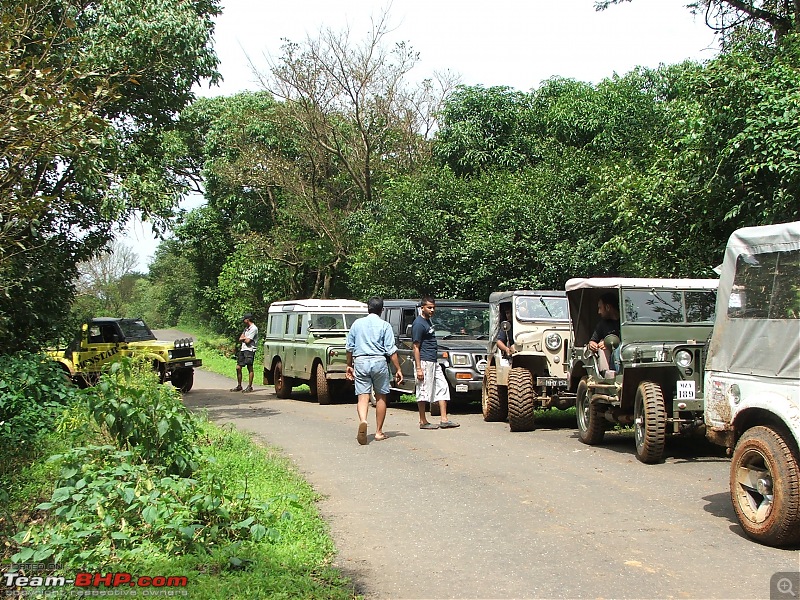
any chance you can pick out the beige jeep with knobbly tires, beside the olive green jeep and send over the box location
[482,290,575,431]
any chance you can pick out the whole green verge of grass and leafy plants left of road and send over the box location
[0,356,358,600]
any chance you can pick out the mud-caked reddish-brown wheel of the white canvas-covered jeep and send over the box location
[730,426,800,546]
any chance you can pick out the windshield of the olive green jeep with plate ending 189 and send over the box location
[622,290,717,323]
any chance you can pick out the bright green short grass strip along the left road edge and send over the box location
[119,420,356,600]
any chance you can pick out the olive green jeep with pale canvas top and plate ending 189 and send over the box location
[566,278,719,463]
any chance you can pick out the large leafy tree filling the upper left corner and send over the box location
[0,0,218,352]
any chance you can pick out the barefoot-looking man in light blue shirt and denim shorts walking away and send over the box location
[345,296,403,446]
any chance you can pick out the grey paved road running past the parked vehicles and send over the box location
[161,336,800,600]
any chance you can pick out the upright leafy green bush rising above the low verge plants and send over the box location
[87,359,197,476]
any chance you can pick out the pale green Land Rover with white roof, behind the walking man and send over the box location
[264,300,367,404]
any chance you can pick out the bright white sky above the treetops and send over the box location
[123,0,716,272]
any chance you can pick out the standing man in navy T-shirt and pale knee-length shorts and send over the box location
[411,296,458,429]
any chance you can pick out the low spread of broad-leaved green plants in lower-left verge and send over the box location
[12,446,299,568]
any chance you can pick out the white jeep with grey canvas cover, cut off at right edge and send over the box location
[705,221,800,546]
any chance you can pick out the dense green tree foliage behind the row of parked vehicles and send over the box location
[153,29,800,324]
